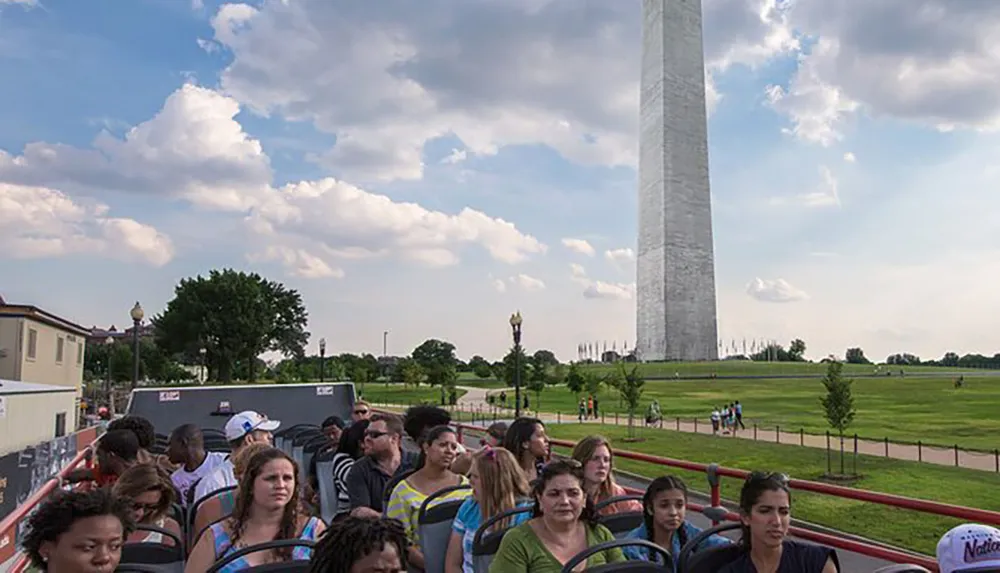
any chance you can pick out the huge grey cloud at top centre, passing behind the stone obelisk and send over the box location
[212,0,797,182]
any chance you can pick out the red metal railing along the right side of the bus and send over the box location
[453,423,1000,571]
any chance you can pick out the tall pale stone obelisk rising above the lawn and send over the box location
[636,0,719,361]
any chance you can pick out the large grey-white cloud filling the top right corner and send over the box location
[768,0,1000,141]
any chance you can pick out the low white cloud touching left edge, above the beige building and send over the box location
[0,183,174,267]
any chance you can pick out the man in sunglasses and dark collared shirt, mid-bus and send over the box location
[347,414,418,517]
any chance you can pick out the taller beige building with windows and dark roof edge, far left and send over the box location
[0,299,89,429]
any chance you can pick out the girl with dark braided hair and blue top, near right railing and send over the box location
[622,476,732,572]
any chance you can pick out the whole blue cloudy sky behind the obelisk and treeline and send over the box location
[0,0,1000,360]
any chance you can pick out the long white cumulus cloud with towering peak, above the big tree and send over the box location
[0,84,546,278]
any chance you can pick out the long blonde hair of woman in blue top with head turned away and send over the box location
[472,446,528,531]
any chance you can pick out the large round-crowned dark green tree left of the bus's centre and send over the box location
[153,269,309,382]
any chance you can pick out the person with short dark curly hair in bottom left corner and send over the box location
[21,489,135,573]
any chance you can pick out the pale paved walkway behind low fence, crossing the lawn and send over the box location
[448,386,997,472]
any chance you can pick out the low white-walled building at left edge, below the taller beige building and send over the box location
[0,379,77,456]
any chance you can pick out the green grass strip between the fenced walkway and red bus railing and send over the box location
[547,424,1000,555]
